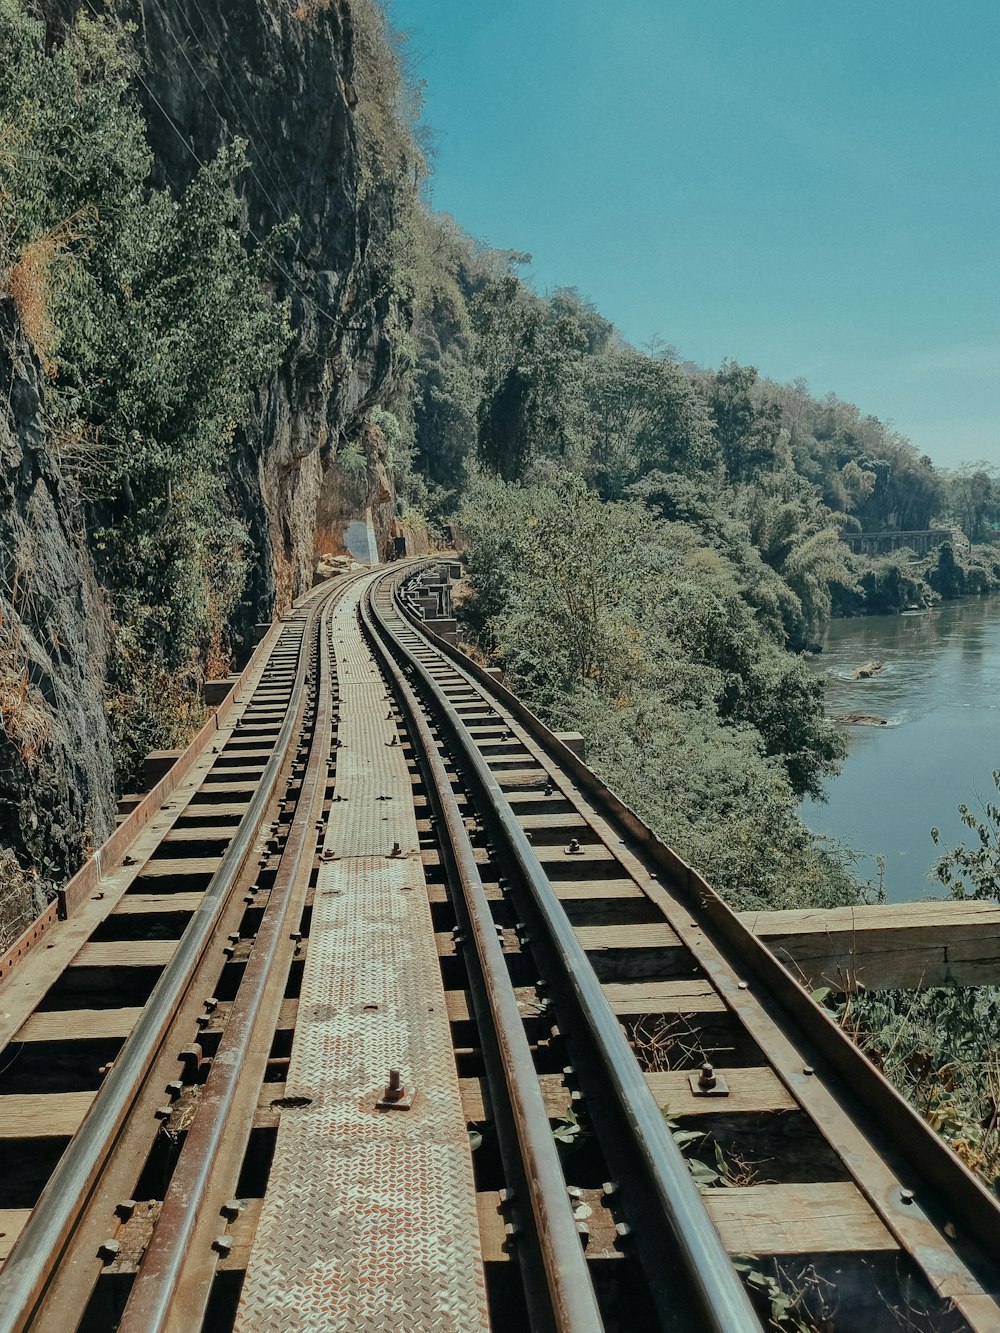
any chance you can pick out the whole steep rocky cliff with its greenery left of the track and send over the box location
[0,0,423,945]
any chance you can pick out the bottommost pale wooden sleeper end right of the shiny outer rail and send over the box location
[701,1182,899,1256]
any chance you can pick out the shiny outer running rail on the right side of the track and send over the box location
[376,576,761,1333]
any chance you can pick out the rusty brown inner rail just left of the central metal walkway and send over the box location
[119,599,333,1333]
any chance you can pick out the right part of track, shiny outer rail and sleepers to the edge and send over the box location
[373,562,1000,1330]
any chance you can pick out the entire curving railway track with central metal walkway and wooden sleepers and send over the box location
[0,557,1000,1333]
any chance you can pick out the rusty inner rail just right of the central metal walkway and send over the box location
[362,588,604,1333]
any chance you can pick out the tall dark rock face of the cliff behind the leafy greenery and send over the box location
[43,0,410,621]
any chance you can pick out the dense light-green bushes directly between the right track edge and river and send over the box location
[463,477,856,906]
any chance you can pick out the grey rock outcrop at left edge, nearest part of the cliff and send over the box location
[0,299,115,946]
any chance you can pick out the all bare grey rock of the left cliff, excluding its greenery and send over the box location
[0,0,405,948]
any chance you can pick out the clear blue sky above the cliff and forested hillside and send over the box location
[391,0,1000,465]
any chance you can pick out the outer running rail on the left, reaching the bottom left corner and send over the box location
[0,575,343,1333]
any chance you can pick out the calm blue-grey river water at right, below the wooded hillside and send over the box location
[801,595,1000,902]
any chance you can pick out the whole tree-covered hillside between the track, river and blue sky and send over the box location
[378,223,1000,906]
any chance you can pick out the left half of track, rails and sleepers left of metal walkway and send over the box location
[0,575,357,1330]
